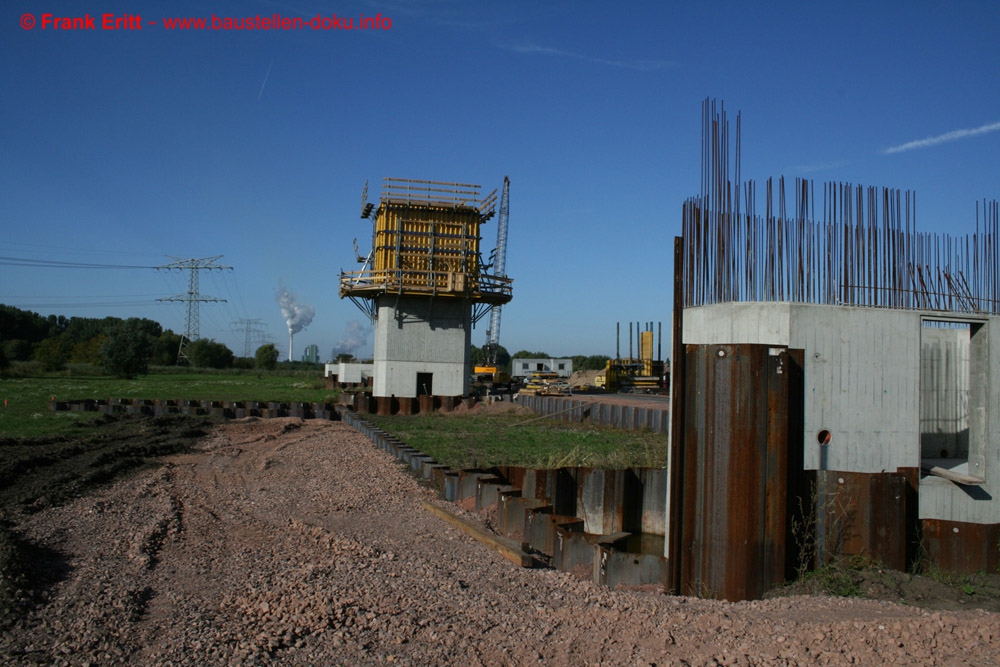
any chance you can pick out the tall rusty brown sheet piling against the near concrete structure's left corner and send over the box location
[671,345,802,601]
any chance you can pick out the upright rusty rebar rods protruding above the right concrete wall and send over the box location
[682,101,1000,313]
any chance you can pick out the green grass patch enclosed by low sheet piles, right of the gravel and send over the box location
[364,411,667,469]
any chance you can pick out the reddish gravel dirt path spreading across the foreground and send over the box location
[0,419,1000,666]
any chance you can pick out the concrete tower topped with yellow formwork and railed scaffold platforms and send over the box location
[340,178,512,412]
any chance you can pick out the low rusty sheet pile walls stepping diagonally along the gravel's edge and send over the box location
[340,408,667,587]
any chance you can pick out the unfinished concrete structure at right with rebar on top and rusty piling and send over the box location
[664,102,1000,599]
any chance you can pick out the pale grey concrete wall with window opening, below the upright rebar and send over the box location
[684,303,1000,523]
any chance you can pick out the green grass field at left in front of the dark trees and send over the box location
[0,366,338,437]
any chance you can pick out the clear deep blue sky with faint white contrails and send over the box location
[0,0,1000,358]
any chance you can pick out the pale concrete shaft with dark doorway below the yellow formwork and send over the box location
[373,295,472,398]
